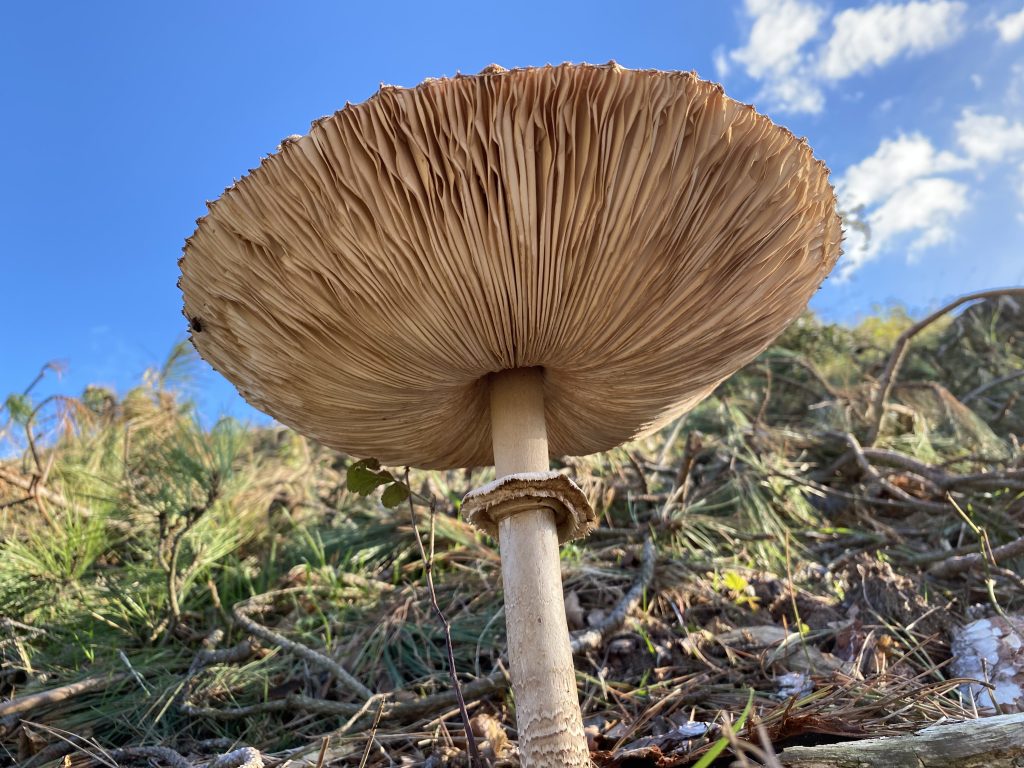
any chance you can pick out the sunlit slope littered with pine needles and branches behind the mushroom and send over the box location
[0,291,1024,768]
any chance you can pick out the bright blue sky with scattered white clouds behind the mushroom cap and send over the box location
[0,0,1024,415]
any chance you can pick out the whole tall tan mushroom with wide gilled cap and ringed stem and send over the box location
[179,62,841,766]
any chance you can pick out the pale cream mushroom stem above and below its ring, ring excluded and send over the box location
[490,368,591,768]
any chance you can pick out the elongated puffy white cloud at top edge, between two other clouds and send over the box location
[819,0,967,80]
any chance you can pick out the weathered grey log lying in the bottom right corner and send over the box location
[779,714,1024,768]
